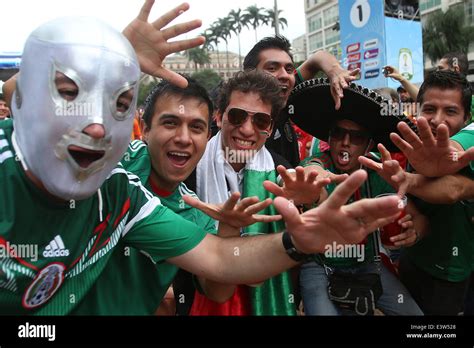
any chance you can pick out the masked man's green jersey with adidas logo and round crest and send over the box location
[0,120,205,315]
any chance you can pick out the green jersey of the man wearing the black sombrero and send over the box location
[301,151,395,267]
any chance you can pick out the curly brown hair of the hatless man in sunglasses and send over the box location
[218,70,285,123]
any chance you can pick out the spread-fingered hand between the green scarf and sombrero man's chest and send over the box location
[263,165,331,205]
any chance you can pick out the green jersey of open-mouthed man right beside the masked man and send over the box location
[74,141,216,315]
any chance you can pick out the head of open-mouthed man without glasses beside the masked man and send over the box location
[142,79,208,188]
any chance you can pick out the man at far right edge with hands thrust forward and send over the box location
[362,71,474,315]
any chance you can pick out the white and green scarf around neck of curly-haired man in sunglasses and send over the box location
[196,132,296,315]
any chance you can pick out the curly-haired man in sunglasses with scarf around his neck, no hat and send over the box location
[185,70,327,315]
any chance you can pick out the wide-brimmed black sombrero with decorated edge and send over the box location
[288,78,418,152]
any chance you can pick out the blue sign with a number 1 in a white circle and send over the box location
[339,0,423,89]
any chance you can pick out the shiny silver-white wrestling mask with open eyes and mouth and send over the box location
[12,17,140,200]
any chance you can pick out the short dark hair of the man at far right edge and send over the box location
[416,70,472,119]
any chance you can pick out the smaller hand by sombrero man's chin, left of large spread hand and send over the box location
[358,144,410,197]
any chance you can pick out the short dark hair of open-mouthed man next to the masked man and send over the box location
[142,75,214,128]
